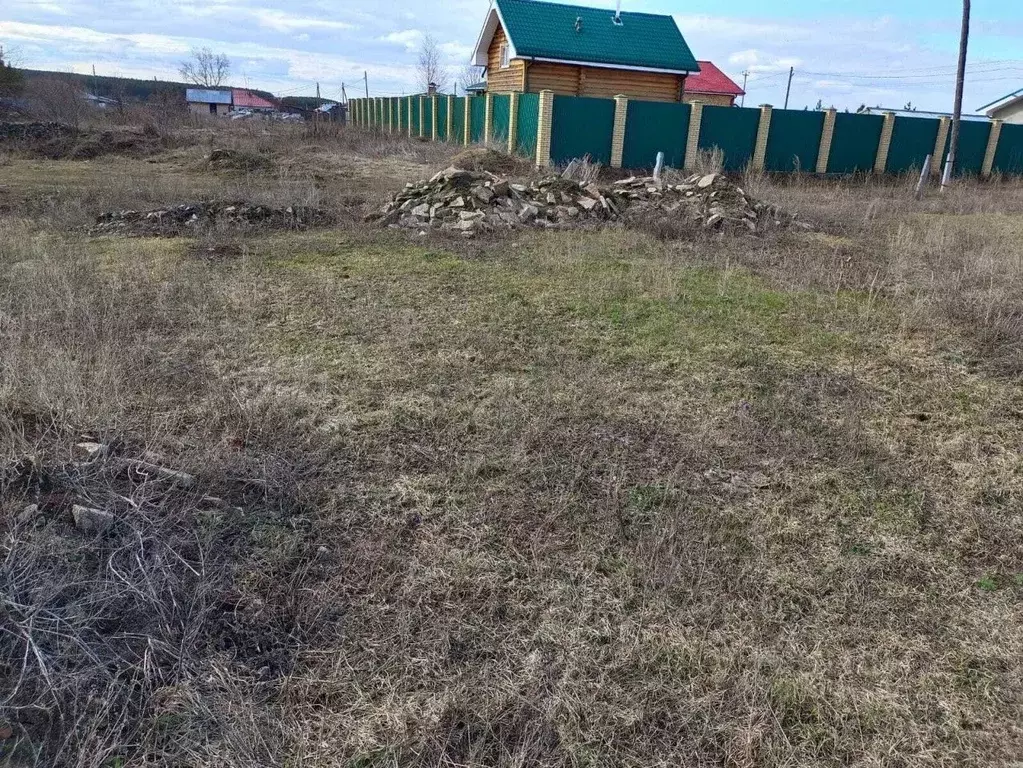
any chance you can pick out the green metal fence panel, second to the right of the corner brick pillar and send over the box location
[622,101,693,168]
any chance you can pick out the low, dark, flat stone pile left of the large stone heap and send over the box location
[88,202,331,237]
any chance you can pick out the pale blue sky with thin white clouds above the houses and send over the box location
[0,0,1023,111]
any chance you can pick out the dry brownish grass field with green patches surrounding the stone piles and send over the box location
[0,117,1023,768]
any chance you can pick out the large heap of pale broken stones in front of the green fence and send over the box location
[367,168,806,237]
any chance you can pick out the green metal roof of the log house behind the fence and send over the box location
[496,0,700,72]
